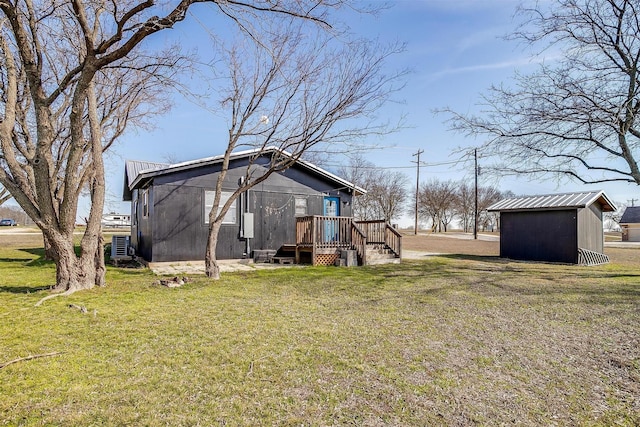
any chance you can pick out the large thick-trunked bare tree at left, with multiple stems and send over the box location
[0,0,350,294]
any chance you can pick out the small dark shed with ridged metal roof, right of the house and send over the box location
[487,191,616,264]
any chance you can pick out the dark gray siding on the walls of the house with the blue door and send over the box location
[132,155,351,262]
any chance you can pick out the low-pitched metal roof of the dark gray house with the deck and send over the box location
[123,147,367,200]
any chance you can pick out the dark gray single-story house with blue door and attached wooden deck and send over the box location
[123,148,400,264]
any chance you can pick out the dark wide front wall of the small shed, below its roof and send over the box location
[500,210,578,264]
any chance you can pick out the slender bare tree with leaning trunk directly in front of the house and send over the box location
[205,20,399,278]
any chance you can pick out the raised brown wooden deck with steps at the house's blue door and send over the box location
[295,215,402,265]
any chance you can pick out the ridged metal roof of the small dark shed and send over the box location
[487,191,616,212]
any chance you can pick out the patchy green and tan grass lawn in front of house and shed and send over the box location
[0,242,640,426]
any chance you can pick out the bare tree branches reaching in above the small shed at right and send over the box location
[449,0,640,184]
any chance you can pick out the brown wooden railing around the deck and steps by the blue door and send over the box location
[296,215,402,264]
